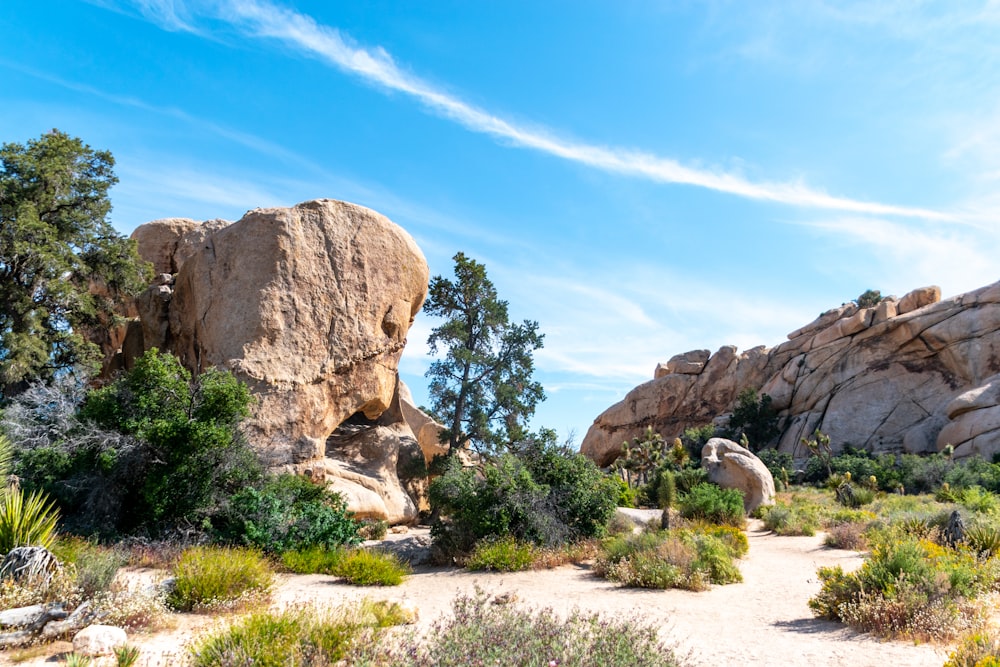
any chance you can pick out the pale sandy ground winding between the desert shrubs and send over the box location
[0,524,947,667]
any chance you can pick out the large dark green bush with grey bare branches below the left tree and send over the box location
[4,349,261,536]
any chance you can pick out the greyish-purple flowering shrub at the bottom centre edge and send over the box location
[378,591,681,667]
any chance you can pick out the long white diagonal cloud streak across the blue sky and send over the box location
[113,0,951,220]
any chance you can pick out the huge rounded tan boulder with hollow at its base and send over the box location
[122,199,429,522]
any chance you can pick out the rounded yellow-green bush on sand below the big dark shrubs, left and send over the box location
[167,547,274,611]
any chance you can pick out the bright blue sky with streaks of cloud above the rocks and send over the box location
[0,0,1000,441]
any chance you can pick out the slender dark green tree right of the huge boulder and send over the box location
[424,253,545,452]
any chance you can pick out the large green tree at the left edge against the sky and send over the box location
[0,130,147,397]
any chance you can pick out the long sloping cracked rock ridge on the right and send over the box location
[581,283,1000,465]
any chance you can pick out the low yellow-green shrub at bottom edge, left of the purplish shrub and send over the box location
[189,601,406,667]
